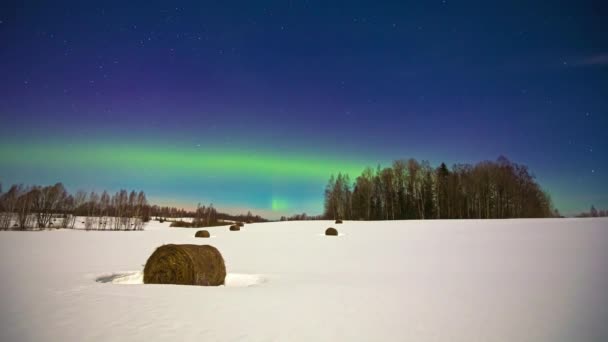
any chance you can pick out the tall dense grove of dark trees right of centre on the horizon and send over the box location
[324,156,559,220]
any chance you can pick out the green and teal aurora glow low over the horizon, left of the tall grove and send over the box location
[0,143,367,218]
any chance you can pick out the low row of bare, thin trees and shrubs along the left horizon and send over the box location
[0,183,265,230]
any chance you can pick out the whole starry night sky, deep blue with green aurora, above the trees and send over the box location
[0,0,608,218]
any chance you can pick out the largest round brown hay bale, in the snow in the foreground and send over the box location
[144,245,226,286]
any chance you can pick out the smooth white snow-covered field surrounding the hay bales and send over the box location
[0,219,608,342]
